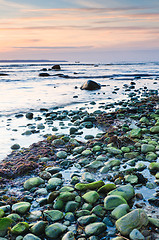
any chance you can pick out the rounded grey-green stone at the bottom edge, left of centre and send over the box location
[45,223,67,239]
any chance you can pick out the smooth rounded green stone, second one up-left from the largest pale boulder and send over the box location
[104,195,127,210]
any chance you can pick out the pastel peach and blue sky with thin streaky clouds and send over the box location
[0,0,159,62]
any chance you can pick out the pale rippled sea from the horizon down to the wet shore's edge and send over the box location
[0,62,159,115]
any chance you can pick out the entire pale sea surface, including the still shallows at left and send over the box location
[0,62,159,160]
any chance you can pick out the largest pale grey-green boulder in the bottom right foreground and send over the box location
[115,209,149,235]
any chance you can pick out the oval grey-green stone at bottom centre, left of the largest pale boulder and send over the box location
[85,222,107,236]
